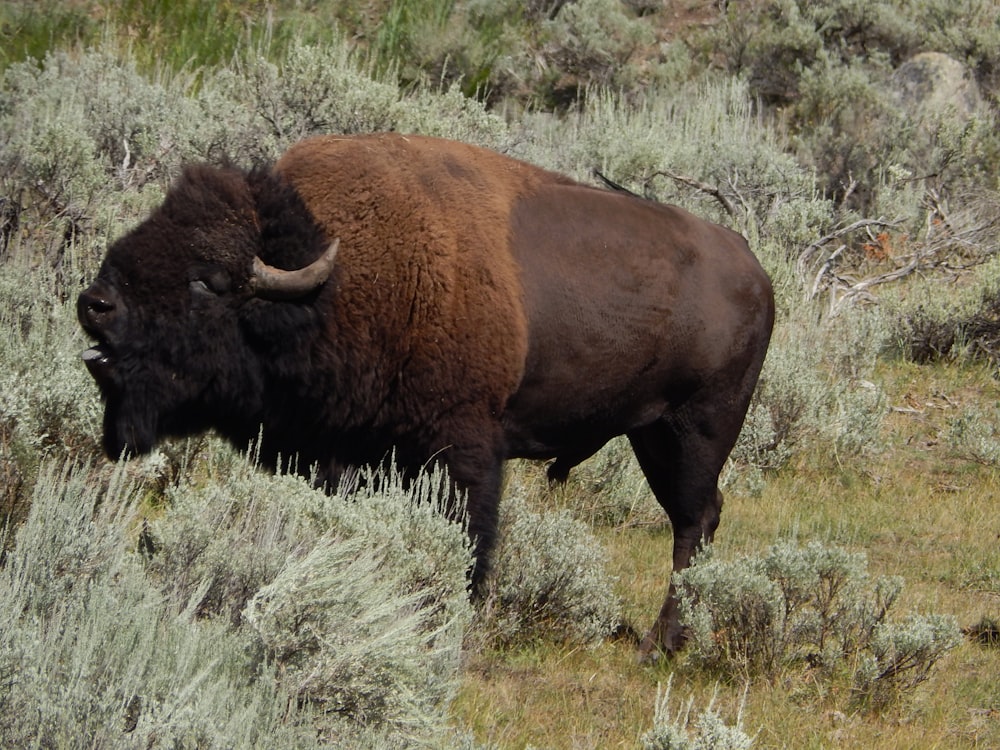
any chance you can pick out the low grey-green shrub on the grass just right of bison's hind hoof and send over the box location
[674,540,960,696]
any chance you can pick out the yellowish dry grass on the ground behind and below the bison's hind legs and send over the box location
[454,364,1000,750]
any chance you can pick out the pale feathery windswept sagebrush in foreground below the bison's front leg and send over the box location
[244,534,464,741]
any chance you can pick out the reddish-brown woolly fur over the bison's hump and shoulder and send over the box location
[276,135,548,449]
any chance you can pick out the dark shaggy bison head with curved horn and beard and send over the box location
[77,167,337,458]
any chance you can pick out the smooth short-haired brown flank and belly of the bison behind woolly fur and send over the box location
[504,186,749,470]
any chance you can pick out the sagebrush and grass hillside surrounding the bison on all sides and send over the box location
[0,0,1000,750]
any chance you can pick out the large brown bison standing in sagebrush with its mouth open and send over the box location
[78,134,774,657]
